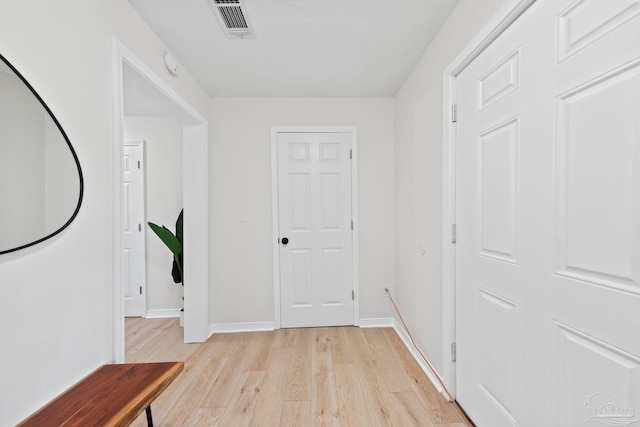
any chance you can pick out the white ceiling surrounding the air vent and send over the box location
[129,0,458,97]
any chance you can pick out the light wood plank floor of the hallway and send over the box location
[126,318,465,427]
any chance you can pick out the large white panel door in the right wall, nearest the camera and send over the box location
[456,0,640,427]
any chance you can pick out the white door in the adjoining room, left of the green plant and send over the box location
[122,142,146,317]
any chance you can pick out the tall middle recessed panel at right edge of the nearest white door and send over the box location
[557,61,640,293]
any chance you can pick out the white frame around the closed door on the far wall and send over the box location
[271,126,360,329]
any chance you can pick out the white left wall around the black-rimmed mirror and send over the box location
[0,0,209,425]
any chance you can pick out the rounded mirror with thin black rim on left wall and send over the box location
[0,55,84,254]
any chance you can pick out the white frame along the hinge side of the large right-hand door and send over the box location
[442,0,536,398]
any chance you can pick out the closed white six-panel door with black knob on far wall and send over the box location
[277,132,354,328]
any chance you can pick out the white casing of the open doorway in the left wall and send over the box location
[111,38,209,363]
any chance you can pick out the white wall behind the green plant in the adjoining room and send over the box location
[124,116,182,314]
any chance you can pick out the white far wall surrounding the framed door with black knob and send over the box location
[209,98,393,324]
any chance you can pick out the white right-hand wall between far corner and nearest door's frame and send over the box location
[395,0,506,370]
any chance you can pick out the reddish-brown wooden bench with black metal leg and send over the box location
[18,362,184,427]
